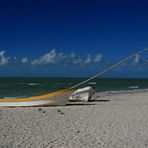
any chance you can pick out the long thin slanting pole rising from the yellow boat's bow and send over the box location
[71,48,148,88]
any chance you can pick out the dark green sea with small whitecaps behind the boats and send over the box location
[0,77,148,98]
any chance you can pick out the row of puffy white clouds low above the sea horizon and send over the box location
[0,49,148,71]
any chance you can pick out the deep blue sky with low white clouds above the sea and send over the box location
[0,0,148,77]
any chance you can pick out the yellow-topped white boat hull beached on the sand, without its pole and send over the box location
[0,88,74,106]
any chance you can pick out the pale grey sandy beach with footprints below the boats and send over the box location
[0,90,148,148]
